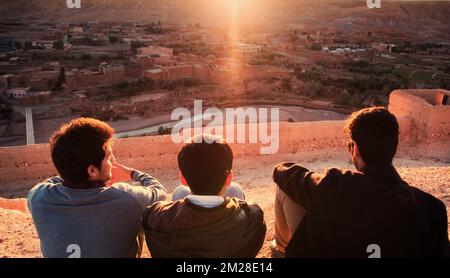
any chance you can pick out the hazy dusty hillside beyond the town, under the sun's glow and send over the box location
[0,0,450,32]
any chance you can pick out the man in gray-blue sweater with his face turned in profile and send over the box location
[28,118,166,258]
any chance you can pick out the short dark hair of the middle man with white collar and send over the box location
[178,134,233,195]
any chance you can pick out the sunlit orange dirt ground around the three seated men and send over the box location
[0,150,450,258]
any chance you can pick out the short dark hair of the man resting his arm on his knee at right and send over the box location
[344,107,399,165]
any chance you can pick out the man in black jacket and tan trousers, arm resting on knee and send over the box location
[273,107,449,257]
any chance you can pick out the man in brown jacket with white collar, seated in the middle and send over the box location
[142,135,266,258]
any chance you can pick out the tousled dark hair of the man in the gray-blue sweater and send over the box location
[50,118,114,182]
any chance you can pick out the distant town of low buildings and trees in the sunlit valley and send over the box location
[0,10,450,146]
